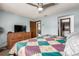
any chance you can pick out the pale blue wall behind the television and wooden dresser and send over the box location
[0,11,30,47]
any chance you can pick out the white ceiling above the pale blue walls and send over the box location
[0,3,79,19]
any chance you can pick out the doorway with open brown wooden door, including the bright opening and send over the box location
[30,21,41,38]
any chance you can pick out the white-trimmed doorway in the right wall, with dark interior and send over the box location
[58,16,74,36]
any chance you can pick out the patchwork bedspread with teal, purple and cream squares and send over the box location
[9,36,65,56]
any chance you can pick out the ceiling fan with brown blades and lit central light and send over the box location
[27,3,56,13]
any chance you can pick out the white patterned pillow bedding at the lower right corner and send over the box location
[64,32,79,56]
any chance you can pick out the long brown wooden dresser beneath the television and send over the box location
[7,32,31,49]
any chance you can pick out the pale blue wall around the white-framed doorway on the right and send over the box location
[40,9,79,35]
